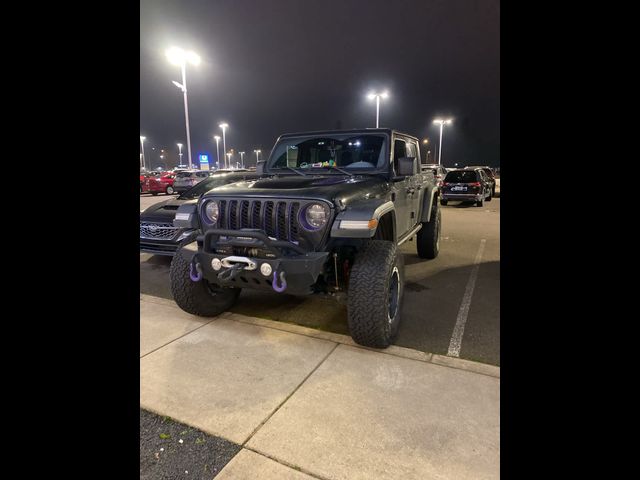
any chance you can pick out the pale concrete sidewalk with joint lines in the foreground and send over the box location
[140,295,500,479]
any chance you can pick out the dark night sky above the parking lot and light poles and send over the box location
[140,0,500,167]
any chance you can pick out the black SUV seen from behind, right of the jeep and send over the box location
[440,168,495,207]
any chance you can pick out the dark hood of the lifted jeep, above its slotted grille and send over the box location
[206,173,390,203]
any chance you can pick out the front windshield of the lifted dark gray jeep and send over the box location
[268,134,387,171]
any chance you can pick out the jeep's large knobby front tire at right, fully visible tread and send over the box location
[347,240,404,348]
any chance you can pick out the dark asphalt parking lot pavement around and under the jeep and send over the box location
[140,194,500,365]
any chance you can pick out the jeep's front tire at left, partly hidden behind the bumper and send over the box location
[169,248,242,317]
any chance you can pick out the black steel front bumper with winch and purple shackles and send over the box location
[191,229,329,295]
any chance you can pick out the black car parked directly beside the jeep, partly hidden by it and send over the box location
[140,172,259,255]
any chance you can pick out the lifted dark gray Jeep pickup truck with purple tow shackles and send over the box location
[170,128,441,348]
